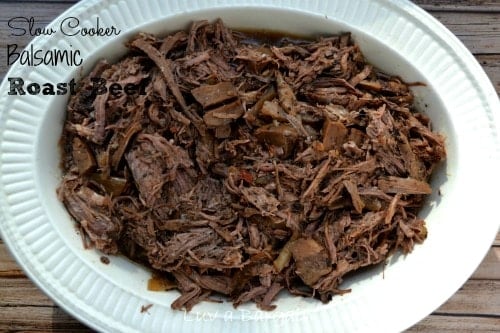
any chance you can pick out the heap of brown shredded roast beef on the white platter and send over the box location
[58,20,446,310]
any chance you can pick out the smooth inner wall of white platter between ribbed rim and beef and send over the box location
[36,1,457,316]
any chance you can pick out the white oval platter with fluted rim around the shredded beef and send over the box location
[0,0,500,333]
